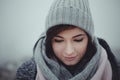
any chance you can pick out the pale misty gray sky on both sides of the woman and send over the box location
[0,0,120,79]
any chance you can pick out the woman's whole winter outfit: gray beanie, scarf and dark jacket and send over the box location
[16,0,119,80]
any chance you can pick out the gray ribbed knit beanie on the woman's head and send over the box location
[46,0,94,40]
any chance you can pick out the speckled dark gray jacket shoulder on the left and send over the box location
[16,58,37,80]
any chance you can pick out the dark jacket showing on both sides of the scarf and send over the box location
[15,38,120,80]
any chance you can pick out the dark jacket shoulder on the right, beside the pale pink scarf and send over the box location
[98,38,120,80]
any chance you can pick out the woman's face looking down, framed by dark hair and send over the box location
[52,28,88,66]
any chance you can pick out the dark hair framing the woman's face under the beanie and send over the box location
[45,24,96,63]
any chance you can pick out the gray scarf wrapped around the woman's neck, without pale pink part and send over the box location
[34,35,101,80]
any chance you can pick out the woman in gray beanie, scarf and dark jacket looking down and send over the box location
[16,0,119,80]
